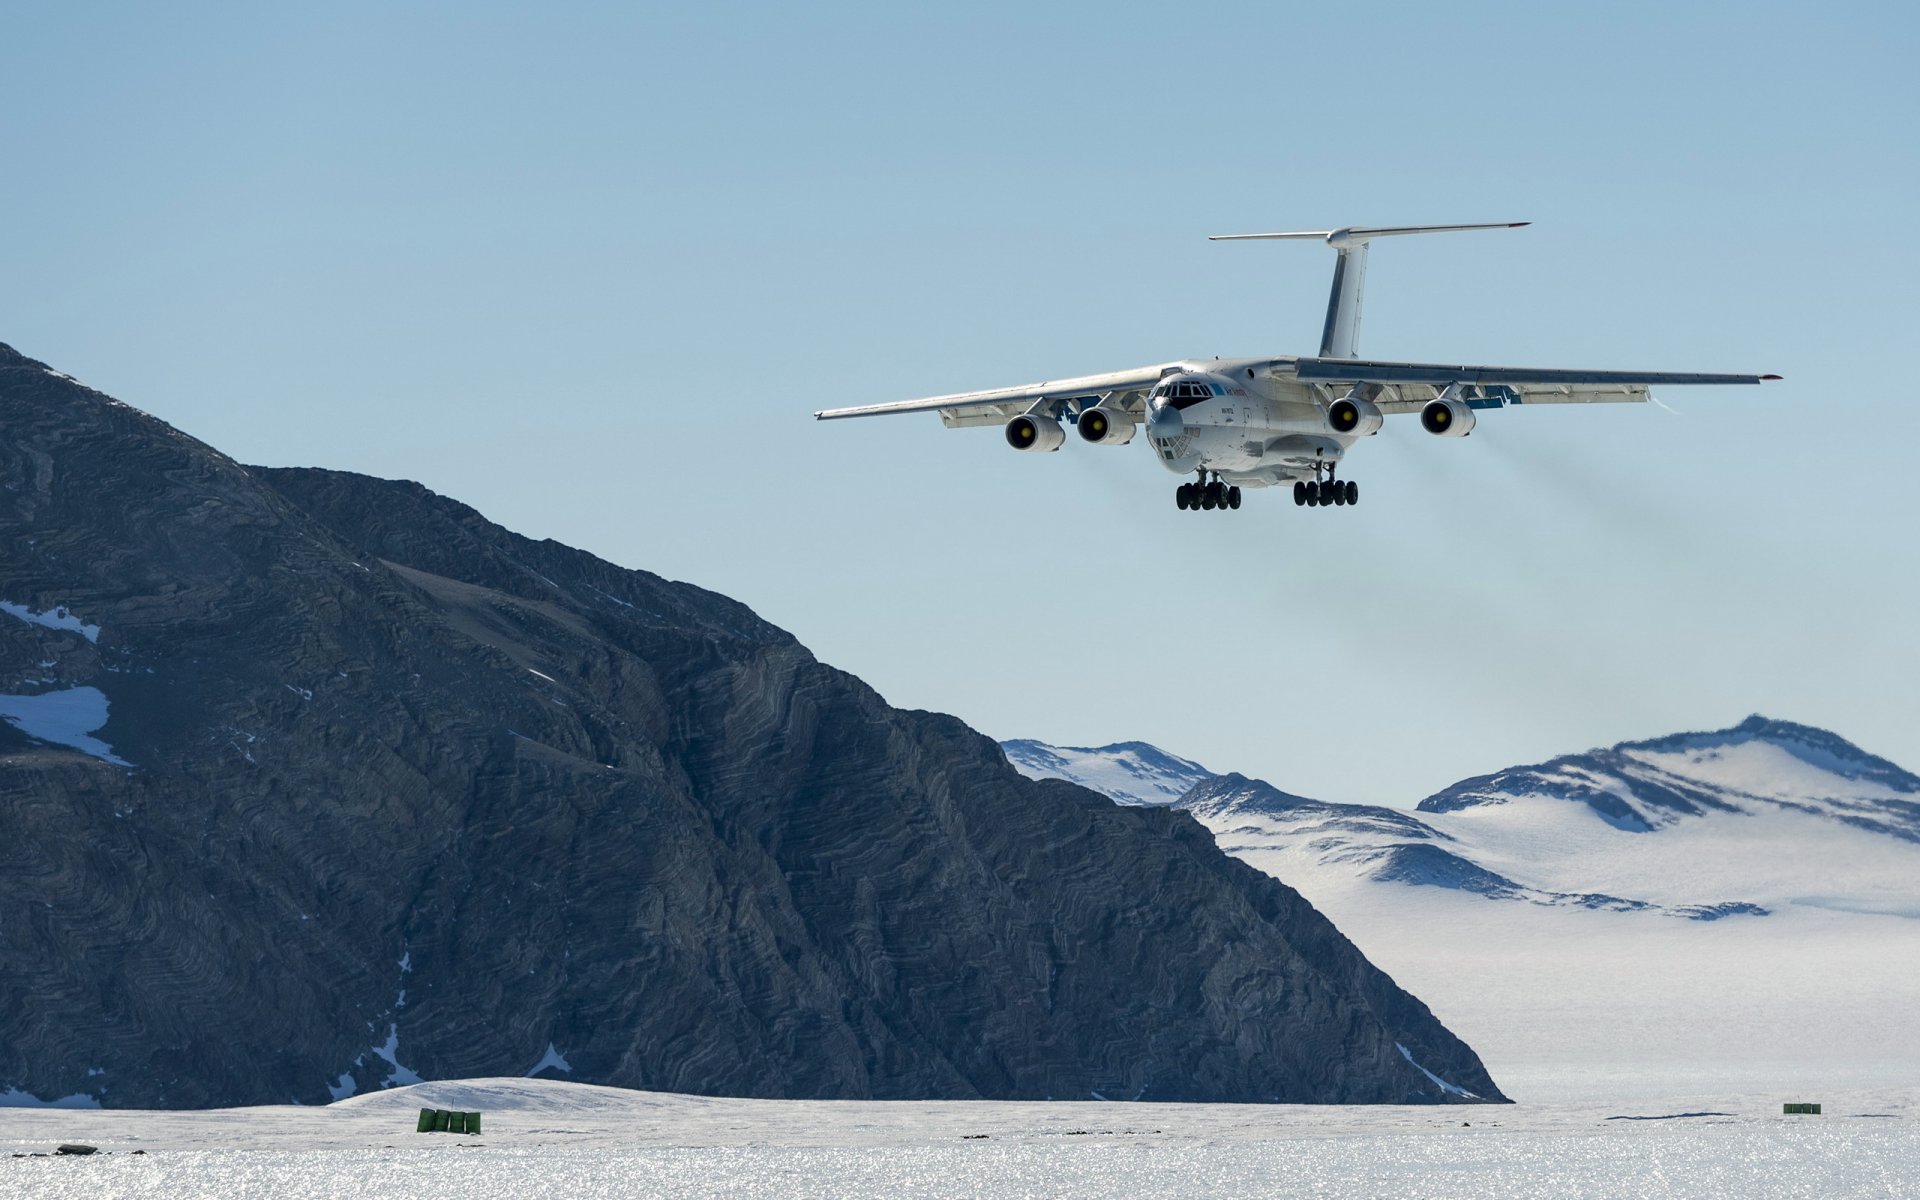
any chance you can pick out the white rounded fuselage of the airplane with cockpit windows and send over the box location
[1140,359,1359,488]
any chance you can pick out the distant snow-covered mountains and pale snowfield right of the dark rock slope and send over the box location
[1004,716,1920,1098]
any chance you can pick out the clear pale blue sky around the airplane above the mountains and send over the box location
[0,2,1920,803]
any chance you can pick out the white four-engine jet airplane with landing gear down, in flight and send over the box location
[814,221,1780,511]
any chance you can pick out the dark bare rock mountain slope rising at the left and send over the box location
[0,346,1501,1106]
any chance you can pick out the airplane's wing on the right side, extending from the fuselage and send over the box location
[1275,359,1780,413]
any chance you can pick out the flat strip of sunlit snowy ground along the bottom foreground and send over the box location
[0,1079,1920,1200]
